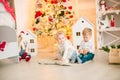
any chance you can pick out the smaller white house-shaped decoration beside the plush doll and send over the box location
[20,30,37,56]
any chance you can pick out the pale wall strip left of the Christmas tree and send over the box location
[14,0,36,32]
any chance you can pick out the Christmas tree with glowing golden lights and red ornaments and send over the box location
[33,0,75,37]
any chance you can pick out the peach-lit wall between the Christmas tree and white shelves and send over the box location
[70,0,97,47]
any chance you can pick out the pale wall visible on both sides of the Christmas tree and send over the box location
[14,0,97,48]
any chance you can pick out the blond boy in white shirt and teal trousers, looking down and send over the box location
[77,28,94,63]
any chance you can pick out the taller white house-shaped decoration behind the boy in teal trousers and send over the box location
[72,17,94,49]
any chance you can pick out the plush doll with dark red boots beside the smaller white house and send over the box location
[18,31,31,62]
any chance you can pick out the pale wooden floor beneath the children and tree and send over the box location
[0,51,120,80]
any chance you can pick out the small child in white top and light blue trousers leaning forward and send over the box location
[56,31,77,63]
